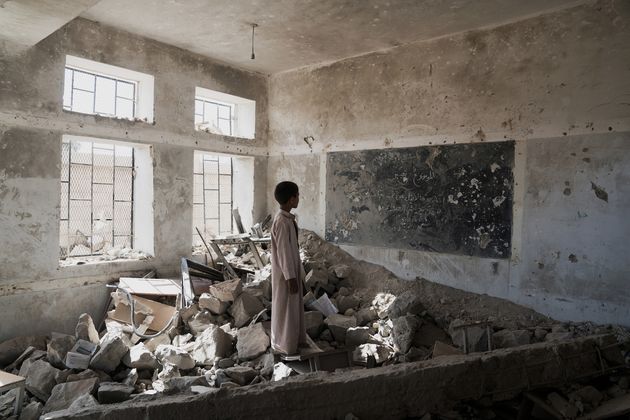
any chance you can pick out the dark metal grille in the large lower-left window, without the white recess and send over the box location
[59,140,134,259]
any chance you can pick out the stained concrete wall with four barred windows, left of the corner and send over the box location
[0,19,268,341]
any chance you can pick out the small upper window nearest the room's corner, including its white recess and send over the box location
[195,87,256,139]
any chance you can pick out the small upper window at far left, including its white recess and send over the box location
[63,56,153,122]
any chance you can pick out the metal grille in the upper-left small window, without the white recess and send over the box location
[63,67,137,119]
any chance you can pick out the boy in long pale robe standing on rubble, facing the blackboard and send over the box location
[271,181,306,354]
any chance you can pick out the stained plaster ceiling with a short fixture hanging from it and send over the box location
[80,0,581,74]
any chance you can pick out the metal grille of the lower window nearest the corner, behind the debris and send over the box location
[193,154,234,246]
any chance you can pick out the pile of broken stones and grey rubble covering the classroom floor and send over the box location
[0,231,630,419]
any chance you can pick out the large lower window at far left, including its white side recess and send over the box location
[59,136,153,260]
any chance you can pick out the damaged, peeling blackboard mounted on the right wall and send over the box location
[326,141,514,258]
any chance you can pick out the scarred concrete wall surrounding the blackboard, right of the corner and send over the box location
[268,0,630,325]
